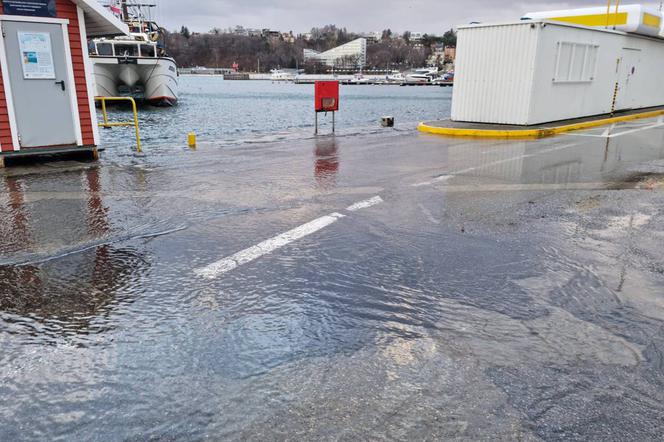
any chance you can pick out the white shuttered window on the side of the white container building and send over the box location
[553,42,599,83]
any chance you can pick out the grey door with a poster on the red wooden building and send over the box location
[2,21,76,148]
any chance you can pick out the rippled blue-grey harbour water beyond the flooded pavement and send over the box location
[102,76,452,155]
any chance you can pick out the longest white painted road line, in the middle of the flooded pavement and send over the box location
[194,213,346,279]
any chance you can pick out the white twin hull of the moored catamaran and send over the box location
[90,56,178,106]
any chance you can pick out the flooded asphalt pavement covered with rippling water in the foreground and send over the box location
[0,121,664,441]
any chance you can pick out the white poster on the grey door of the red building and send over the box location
[18,32,55,80]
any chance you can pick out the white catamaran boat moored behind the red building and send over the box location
[90,0,178,106]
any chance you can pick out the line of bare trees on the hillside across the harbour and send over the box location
[164,25,456,72]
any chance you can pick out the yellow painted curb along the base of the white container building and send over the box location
[417,109,664,138]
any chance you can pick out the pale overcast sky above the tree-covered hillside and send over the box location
[156,0,659,34]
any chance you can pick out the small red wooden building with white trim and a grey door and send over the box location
[0,0,128,166]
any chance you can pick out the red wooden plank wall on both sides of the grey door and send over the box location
[0,0,96,152]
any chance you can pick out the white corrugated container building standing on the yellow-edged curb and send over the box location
[452,21,664,125]
